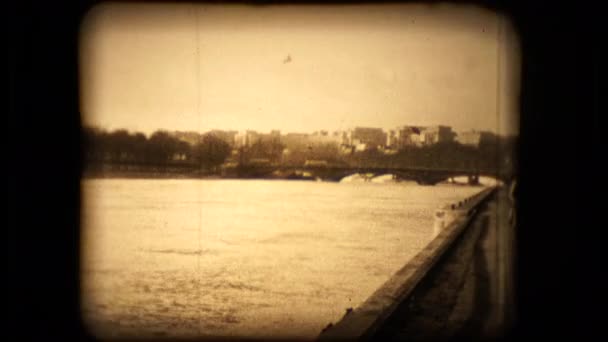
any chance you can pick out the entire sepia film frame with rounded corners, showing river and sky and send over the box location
[78,2,521,341]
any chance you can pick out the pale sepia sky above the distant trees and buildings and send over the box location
[80,4,520,134]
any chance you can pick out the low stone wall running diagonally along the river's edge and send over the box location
[318,188,495,340]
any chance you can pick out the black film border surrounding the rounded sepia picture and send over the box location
[4,0,602,340]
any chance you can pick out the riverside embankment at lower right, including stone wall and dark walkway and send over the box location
[319,188,515,341]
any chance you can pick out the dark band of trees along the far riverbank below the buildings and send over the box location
[82,127,517,176]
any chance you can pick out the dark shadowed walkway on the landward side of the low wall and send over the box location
[374,187,515,340]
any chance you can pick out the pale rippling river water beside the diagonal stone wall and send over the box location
[81,179,481,339]
